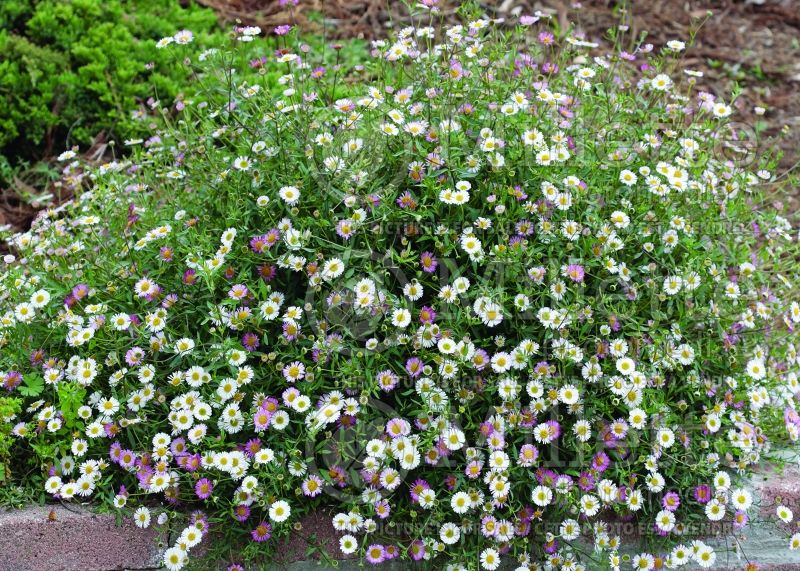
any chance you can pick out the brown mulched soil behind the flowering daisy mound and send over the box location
[0,0,800,237]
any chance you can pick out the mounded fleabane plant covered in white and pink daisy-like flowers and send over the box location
[0,4,800,571]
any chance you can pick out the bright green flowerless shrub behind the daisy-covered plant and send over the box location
[0,0,218,169]
